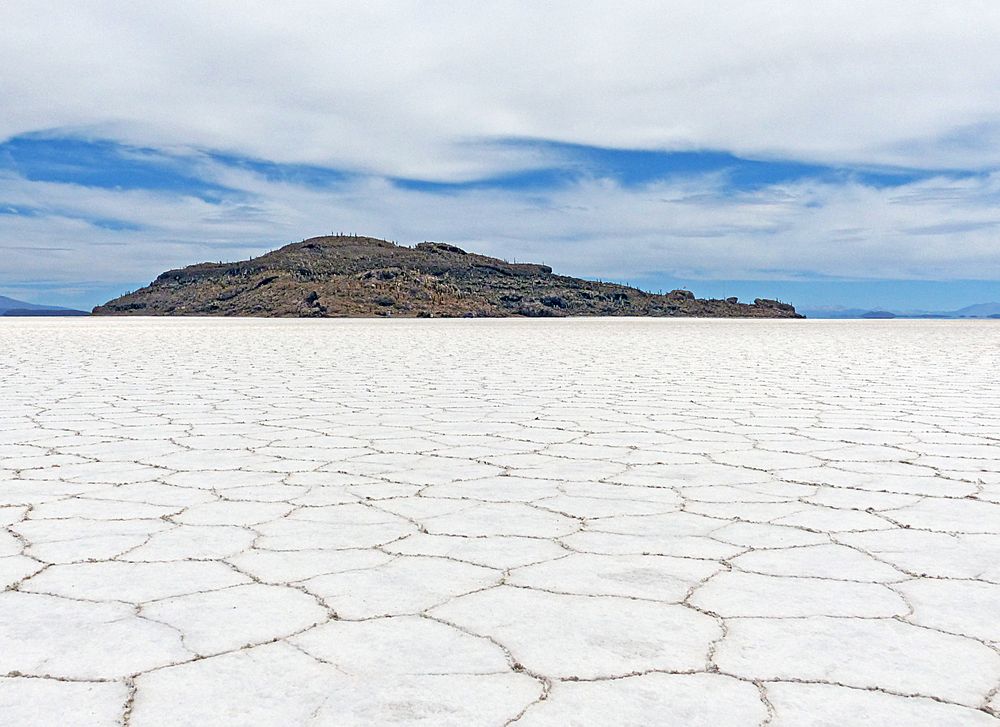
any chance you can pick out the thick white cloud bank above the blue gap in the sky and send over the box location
[0,0,1000,179]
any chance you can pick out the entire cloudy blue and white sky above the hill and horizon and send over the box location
[0,0,1000,310]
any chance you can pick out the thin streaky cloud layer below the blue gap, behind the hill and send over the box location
[0,148,1000,292]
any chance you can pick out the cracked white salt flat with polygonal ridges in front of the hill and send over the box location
[0,319,1000,727]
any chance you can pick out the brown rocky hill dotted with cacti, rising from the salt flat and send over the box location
[94,236,801,318]
